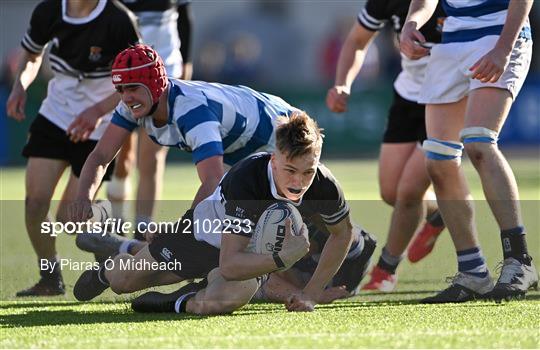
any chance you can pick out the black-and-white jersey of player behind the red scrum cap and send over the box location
[121,0,189,78]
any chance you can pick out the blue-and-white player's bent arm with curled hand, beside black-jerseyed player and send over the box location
[399,0,437,60]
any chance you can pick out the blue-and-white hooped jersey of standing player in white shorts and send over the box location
[442,0,531,43]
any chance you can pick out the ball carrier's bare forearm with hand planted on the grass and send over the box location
[287,216,353,311]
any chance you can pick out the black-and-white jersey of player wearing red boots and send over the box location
[358,0,446,101]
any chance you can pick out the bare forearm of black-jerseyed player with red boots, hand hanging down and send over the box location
[326,22,377,113]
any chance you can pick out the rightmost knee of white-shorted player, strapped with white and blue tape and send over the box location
[459,127,498,166]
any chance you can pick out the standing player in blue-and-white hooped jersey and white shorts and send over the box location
[401,0,538,303]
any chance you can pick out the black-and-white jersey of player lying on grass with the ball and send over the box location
[193,153,349,248]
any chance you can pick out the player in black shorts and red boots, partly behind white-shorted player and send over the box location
[326,0,444,292]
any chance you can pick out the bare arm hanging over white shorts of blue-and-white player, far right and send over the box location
[469,0,533,83]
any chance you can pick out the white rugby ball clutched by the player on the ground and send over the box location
[252,202,307,254]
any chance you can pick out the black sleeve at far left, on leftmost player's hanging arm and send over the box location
[21,2,56,55]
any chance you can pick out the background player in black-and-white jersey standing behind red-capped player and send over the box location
[107,0,193,240]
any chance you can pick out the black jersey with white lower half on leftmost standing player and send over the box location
[21,0,139,140]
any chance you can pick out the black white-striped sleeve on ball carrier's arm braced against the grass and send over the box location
[318,166,349,226]
